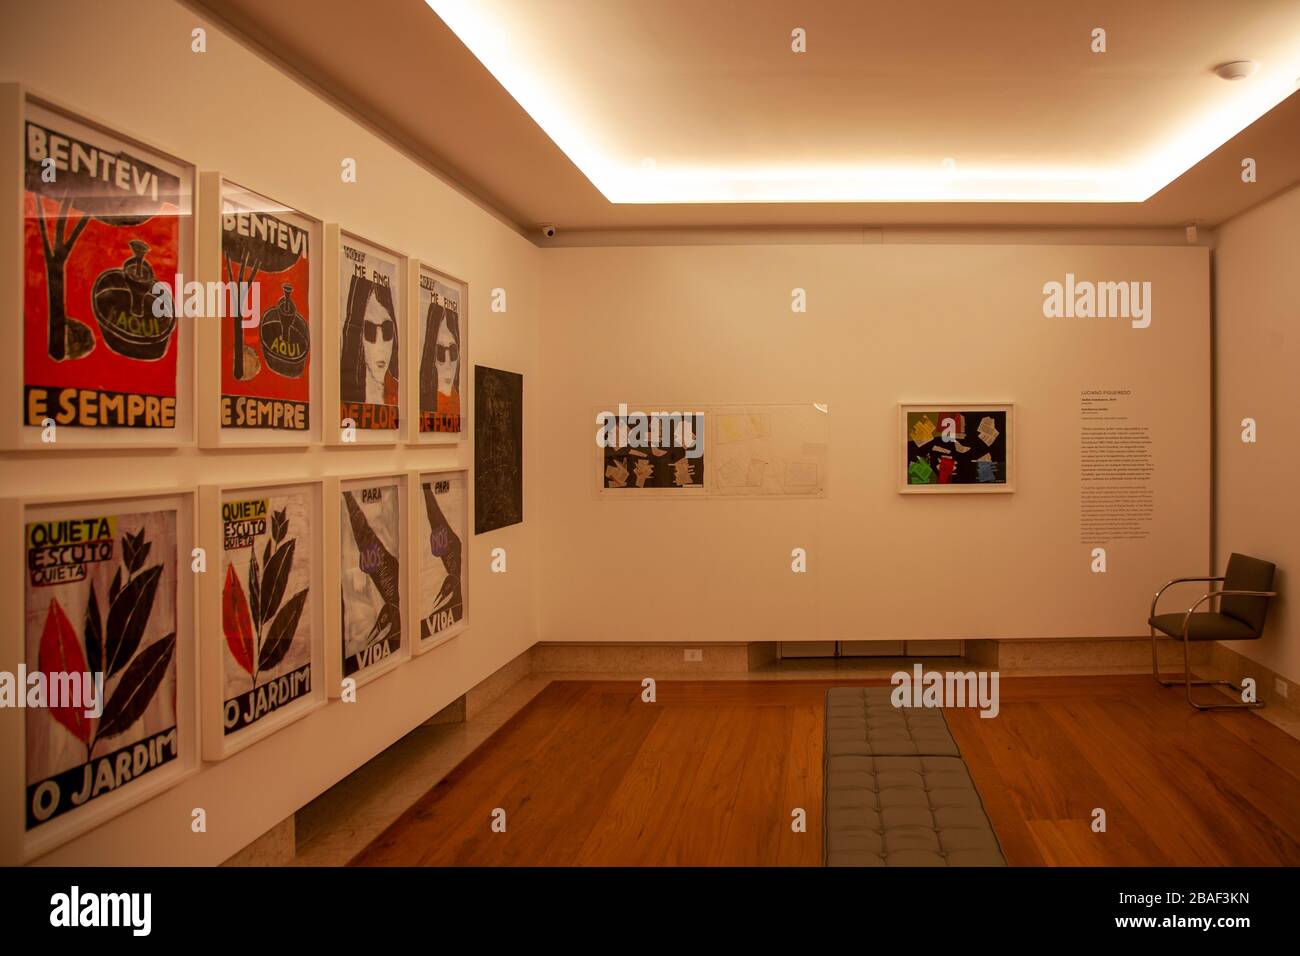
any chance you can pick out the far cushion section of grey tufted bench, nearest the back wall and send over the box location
[826,687,959,757]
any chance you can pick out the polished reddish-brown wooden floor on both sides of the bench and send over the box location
[352,676,1300,866]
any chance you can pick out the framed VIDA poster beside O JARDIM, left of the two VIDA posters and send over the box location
[330,475,411,696]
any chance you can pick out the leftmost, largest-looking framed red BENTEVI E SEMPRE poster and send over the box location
[0,85,194,449]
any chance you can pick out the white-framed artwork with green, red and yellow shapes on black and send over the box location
[898,402,1015,494]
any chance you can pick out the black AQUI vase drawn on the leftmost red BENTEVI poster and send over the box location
[91,239,176,360]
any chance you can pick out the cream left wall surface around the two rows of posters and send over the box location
[0,0,541,865]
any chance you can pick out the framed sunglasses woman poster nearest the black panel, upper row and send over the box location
[407,265,469,445]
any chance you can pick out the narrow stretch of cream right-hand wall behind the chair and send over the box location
[1214,189,1300,689]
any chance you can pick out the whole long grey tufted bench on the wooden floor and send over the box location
[823,687,1006,866]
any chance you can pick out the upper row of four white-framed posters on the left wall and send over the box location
[0,83,469,450]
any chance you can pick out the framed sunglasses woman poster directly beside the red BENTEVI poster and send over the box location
[325,225,410,445]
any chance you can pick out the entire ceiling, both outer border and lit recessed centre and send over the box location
[197,0,1300,238]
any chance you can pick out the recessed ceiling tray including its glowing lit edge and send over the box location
[428,0,1300,203]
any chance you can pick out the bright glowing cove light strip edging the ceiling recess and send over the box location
[425,0,1300,204]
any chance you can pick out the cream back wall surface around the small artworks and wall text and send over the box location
[540,245,1210,641]
